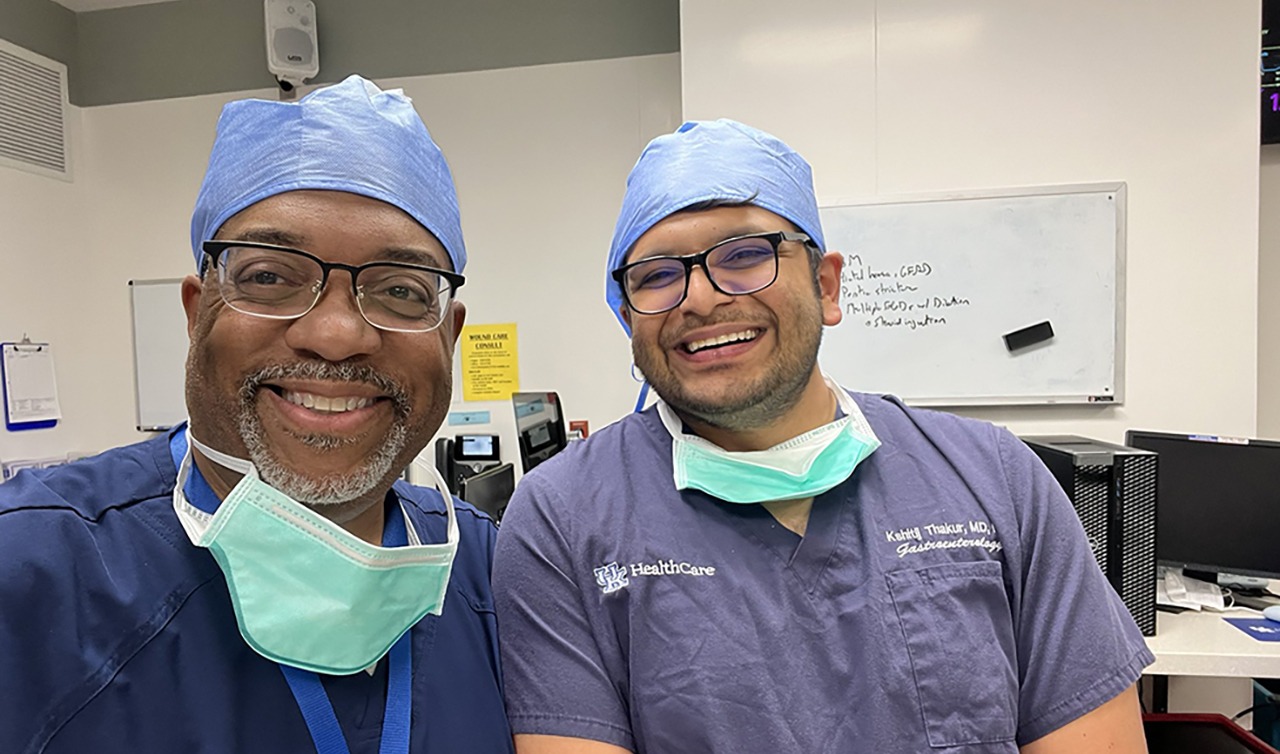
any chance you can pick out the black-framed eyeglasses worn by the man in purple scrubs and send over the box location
[613,230,817,314]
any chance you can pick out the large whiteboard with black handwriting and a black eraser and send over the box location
[819,183,1125,406]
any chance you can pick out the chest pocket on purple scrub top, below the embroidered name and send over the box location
[884,561,1018,748]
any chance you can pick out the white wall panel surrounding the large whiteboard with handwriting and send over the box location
[681,0,1260,440]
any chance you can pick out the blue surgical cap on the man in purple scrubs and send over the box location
[604,120,827,334]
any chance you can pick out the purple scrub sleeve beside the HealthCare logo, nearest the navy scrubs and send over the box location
[493,474,635,750]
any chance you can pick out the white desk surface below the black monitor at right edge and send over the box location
[1144,611,1280,678]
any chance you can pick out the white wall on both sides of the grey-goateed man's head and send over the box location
[0,55,680,460]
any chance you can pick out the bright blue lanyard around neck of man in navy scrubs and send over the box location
[169,430,413,754]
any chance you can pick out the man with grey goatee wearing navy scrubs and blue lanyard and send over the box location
[0,77,511,754]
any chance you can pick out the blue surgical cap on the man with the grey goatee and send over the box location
[191,76,467,273]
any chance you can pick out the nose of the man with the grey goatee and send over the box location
[284,270,383,361]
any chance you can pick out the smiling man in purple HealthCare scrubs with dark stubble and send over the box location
[494,120,1152,754]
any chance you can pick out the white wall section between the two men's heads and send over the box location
[383,55,680,430]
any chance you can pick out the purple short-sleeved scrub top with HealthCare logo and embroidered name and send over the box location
[494,394,1153,754]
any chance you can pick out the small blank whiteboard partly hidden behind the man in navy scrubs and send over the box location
[129,279,187,431]
